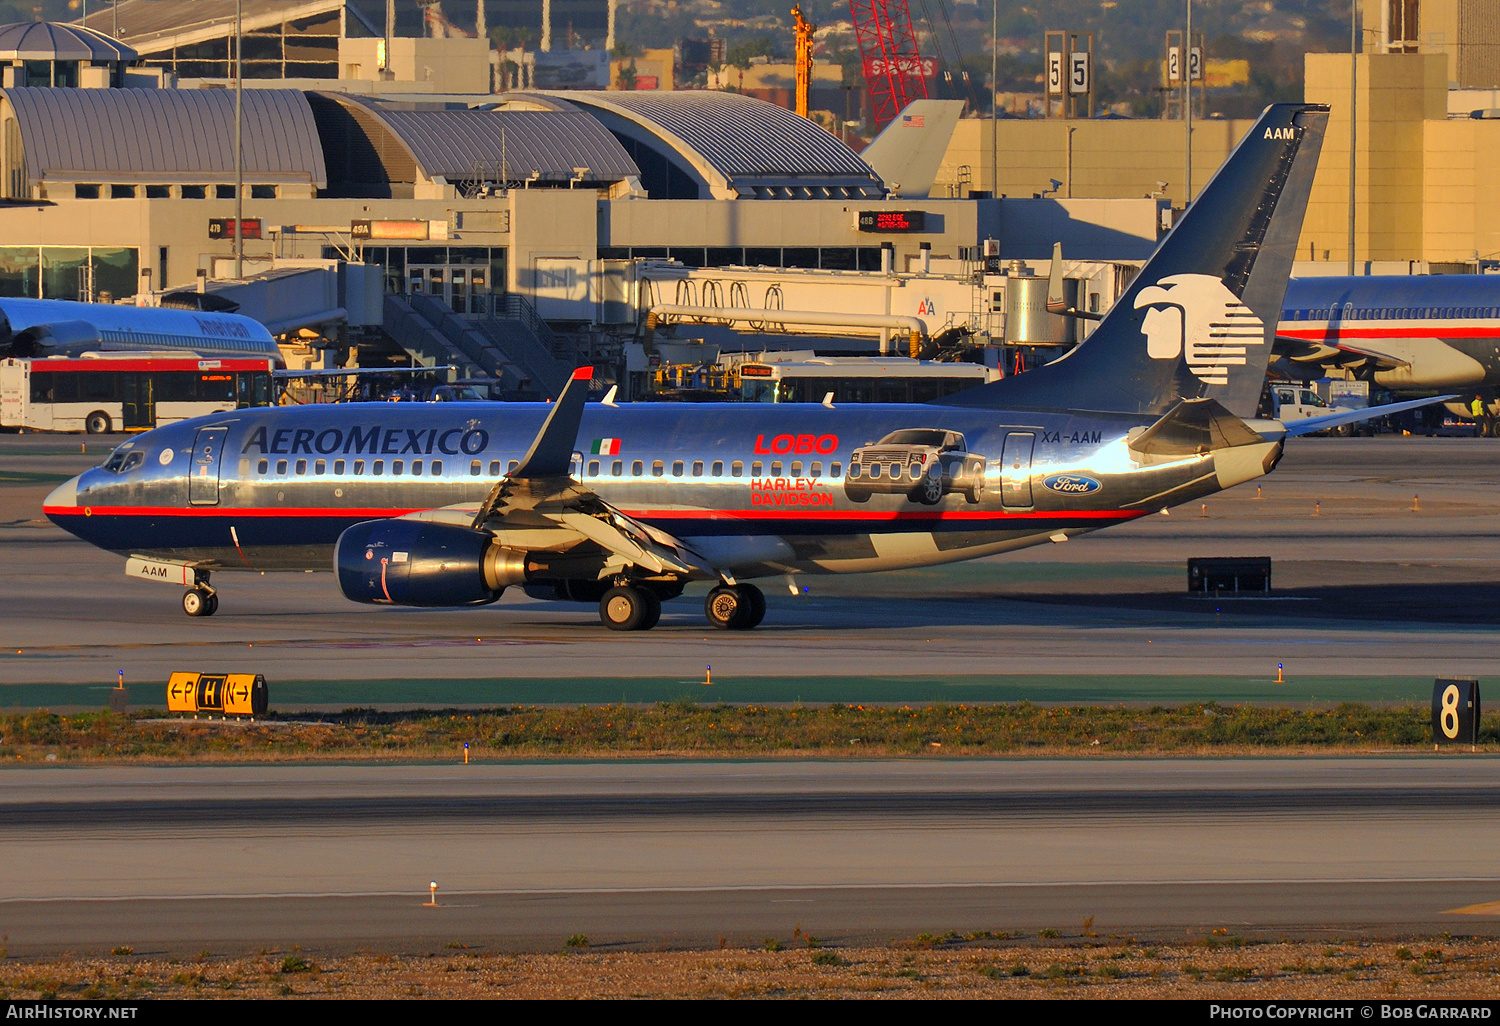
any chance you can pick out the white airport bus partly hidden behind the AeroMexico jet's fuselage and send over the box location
[738,357,1001,402]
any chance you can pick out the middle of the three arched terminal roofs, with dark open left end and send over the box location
[315,93,641,196]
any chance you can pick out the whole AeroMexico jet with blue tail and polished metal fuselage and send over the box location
[45,105,1446,630]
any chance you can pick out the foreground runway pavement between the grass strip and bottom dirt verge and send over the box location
[0,756,1500,954]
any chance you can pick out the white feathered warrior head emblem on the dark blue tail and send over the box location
[1136,275,1266,386]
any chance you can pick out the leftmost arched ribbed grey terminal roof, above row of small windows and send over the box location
[0,89,327,188]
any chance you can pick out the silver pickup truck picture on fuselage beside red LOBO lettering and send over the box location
[845,428,986,506]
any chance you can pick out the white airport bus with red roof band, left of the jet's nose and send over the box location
[0,353,276,435]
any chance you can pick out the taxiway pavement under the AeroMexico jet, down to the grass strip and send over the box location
[0,435,1500,707]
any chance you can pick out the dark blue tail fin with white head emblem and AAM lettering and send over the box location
[944,104,1328,417]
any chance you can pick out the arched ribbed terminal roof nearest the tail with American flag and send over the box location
[504,90,884,200]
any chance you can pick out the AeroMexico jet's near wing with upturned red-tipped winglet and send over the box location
[402,366,720,581]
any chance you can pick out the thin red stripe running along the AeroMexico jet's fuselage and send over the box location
[42,506,1145,524]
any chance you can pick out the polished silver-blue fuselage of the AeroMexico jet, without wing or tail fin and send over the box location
[45,404,1271,576]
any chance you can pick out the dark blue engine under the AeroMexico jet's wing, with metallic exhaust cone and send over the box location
[333,519,527,606]
